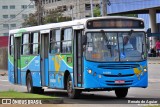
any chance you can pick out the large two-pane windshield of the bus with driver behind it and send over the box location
[85,32,145,62]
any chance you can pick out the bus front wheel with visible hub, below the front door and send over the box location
[67,75,81,99]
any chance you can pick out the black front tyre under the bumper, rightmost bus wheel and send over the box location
[115,88,128,98]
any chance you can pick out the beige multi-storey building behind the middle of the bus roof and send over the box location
[42,0,100,19]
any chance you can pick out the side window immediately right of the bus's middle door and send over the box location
[50,30,60,54]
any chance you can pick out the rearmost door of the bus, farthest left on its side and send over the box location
[14,37,21,84]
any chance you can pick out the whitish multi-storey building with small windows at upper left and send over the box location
[0,0,35,36]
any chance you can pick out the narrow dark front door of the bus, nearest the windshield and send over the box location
[73,30,83,88]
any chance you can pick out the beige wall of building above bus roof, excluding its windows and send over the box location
[42,0,99,19]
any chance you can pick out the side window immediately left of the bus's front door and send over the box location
[61,28,72,53]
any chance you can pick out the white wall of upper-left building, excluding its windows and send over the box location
[0,0,35,36]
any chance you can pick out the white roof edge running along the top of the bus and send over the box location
[9,16,143,34]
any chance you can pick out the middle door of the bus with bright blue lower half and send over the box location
[40,31,49,86]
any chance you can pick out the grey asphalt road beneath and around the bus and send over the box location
[0,61,160,104]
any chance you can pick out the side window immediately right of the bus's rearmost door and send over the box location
[22,34,30,55]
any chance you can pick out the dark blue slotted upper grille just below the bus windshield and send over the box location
[98,64,140,69]
